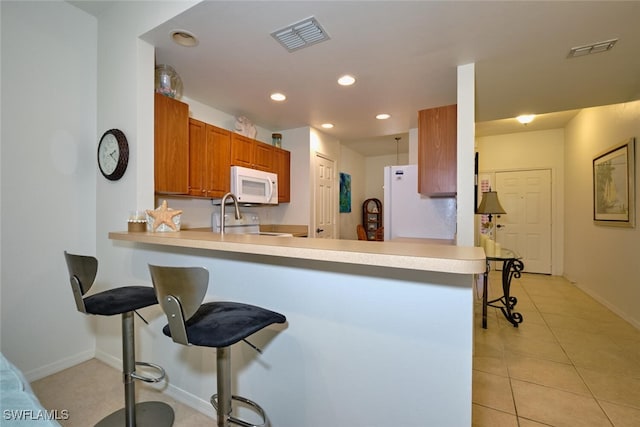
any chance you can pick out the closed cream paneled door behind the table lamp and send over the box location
[495,169,551,274]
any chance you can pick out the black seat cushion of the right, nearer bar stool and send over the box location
[162,302,287,347]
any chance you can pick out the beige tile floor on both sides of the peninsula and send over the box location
[32,272,640,427]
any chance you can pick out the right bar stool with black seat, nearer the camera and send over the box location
[149,265,287,427]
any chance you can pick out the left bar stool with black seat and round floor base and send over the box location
[64,251,174,427]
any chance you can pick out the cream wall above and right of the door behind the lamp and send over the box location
[476,129,565,275]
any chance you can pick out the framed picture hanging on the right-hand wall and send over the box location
[593,138,636,228]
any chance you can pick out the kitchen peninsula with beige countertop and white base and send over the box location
[109,230,485,427]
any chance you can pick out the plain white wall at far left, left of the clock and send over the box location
[0,2,99,380]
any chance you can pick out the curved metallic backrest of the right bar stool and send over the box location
[149,264,209,345]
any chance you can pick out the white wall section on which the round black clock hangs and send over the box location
[90,1,197,366]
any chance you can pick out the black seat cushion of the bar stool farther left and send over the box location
[84,286,158,316]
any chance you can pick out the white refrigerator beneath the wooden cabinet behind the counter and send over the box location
[382,165,456,241]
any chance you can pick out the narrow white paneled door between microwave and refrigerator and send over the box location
[313,153,336,239]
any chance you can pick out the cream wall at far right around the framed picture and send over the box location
[564,101,640,328]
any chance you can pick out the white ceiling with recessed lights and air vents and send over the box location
[73,1,640,155]
